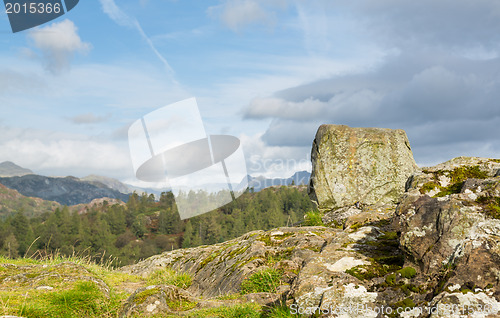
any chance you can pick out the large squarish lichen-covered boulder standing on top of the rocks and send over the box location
[309,125,418,211]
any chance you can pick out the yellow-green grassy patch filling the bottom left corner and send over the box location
[0,254,133,318]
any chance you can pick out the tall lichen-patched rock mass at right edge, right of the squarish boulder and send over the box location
[394,157,500,317]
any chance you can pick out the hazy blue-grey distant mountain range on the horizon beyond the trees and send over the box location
[0,161,311,205]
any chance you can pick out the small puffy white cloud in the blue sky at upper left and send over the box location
[28,19,92,74]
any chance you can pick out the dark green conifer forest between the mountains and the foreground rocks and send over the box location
[0,187,313,266]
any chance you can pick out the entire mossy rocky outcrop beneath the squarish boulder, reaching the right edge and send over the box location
[123,158,500,317]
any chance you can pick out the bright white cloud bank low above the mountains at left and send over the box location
[0,126,133,178]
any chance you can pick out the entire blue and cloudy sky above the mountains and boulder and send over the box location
[0,0,500,185]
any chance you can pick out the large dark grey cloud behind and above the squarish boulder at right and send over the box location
[246,56,500,162]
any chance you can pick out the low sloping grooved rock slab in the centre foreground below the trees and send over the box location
[121,227,339,297]
